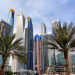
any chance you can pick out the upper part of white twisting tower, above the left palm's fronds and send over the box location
[16,13,25,46]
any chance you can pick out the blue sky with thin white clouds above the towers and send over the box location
[0,0,75,35]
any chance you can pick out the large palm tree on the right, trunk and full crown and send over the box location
[43,22,75,75]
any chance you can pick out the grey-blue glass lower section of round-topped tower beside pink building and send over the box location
[40,35,49,71]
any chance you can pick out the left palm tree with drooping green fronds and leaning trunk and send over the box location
[0,33,27,75]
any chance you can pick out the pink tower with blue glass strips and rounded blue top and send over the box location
[33,35,42,75]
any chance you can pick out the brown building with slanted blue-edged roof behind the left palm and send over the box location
[0,19,13,70]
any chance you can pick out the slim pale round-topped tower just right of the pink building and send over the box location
[40,23,49,71]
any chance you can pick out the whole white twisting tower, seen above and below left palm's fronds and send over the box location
[12,13,25,72]
